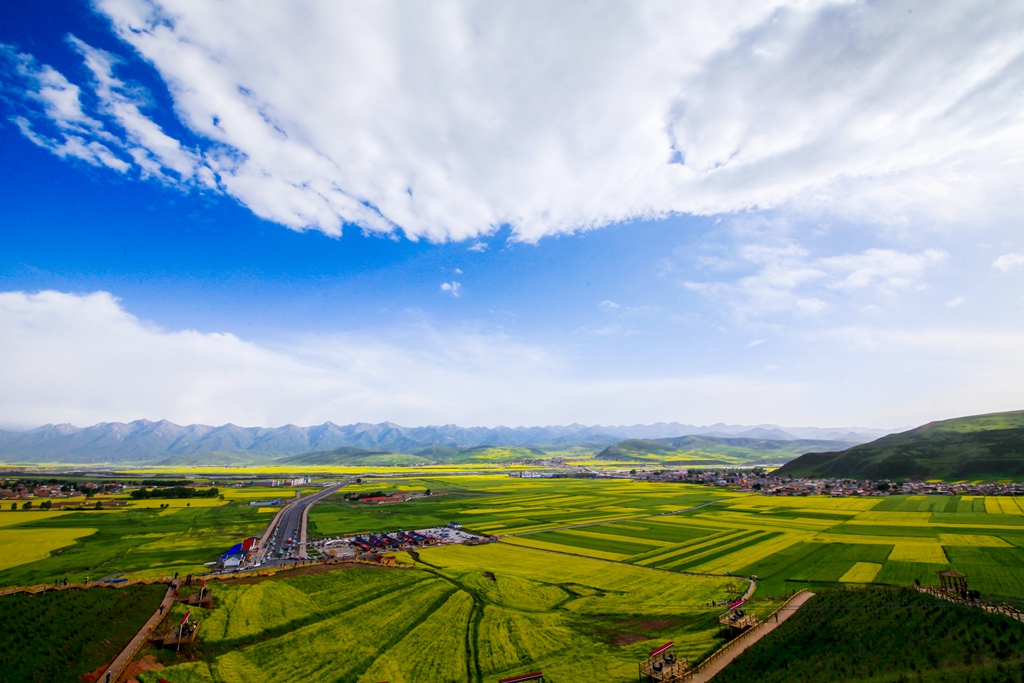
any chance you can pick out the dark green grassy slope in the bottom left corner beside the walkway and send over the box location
[0,585,167,683]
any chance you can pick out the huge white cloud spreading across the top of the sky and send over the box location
[4,0,1024,240]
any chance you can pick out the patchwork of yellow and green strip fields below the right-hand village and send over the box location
[493,496,1024,598]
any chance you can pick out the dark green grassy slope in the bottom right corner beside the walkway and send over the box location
[715,589,1024,683]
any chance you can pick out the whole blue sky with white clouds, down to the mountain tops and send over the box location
[0,0,1024,428]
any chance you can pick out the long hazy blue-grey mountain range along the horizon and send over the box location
[0,420,889,464]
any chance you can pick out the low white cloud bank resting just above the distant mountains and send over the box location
[0,292,823,427]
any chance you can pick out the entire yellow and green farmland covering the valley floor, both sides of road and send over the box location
[6,474,1024,683]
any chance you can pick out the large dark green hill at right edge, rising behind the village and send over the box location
[777,411,1024,480]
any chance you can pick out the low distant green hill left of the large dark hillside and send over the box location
[595,436,850,466]
